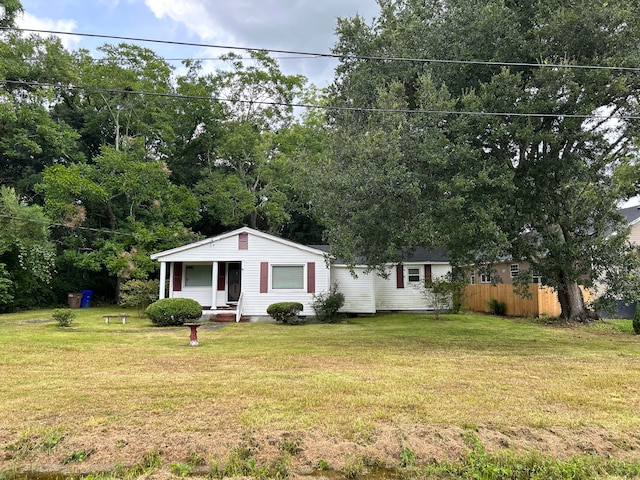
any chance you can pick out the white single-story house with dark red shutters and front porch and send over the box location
[151,227,451,321]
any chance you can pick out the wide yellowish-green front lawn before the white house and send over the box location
[0,308,640,478]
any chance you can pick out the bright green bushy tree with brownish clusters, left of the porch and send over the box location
[39,140,199,295]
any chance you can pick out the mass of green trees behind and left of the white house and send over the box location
[0,1,322,310]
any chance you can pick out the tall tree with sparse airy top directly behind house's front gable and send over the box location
[195,52,306,231]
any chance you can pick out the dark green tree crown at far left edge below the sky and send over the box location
[0,32,82,198]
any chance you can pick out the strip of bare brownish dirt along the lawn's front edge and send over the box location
[0,424,640,478]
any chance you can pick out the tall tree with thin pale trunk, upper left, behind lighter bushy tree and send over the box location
[54,43,175,159]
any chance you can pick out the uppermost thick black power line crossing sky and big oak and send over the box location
[5,27,640,72]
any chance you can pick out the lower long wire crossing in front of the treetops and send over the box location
[0,80,640,120]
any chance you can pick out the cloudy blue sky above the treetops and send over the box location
[18,0,379,87]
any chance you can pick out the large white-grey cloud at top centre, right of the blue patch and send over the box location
[145,0,379,86]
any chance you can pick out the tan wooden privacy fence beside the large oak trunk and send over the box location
[465,283,590,317]
